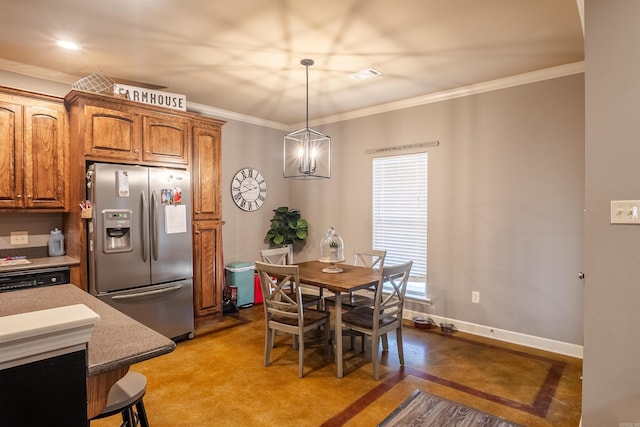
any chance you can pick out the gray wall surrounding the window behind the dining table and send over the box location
[290,74,584,345]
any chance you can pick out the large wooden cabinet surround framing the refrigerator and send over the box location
[63,91,225,333]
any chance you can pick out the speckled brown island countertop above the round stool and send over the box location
[0,285,176,376]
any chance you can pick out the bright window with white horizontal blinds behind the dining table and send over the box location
[372,153,428,299]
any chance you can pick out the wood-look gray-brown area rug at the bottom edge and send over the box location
[378,390,522,427]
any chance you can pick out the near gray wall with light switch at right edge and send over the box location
[583,0,640,427]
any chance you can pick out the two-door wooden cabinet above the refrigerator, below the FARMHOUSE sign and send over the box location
[65,91,191,168]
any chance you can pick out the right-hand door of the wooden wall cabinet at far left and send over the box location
[23,105,68,208]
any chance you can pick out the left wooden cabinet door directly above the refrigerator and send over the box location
[84,105,142,161]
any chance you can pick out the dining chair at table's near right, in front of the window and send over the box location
[342,261,413,380]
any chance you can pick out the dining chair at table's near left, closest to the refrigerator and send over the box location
[255,261,331,378]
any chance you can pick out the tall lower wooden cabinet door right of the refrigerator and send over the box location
[193,220,224,320]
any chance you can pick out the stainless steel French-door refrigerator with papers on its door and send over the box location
[87,163,194,338]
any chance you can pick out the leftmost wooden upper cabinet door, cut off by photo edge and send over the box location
[0,100,23,208]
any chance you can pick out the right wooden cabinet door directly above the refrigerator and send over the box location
[142,114,189,165]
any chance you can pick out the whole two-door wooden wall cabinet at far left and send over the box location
[0,88,68,211]
